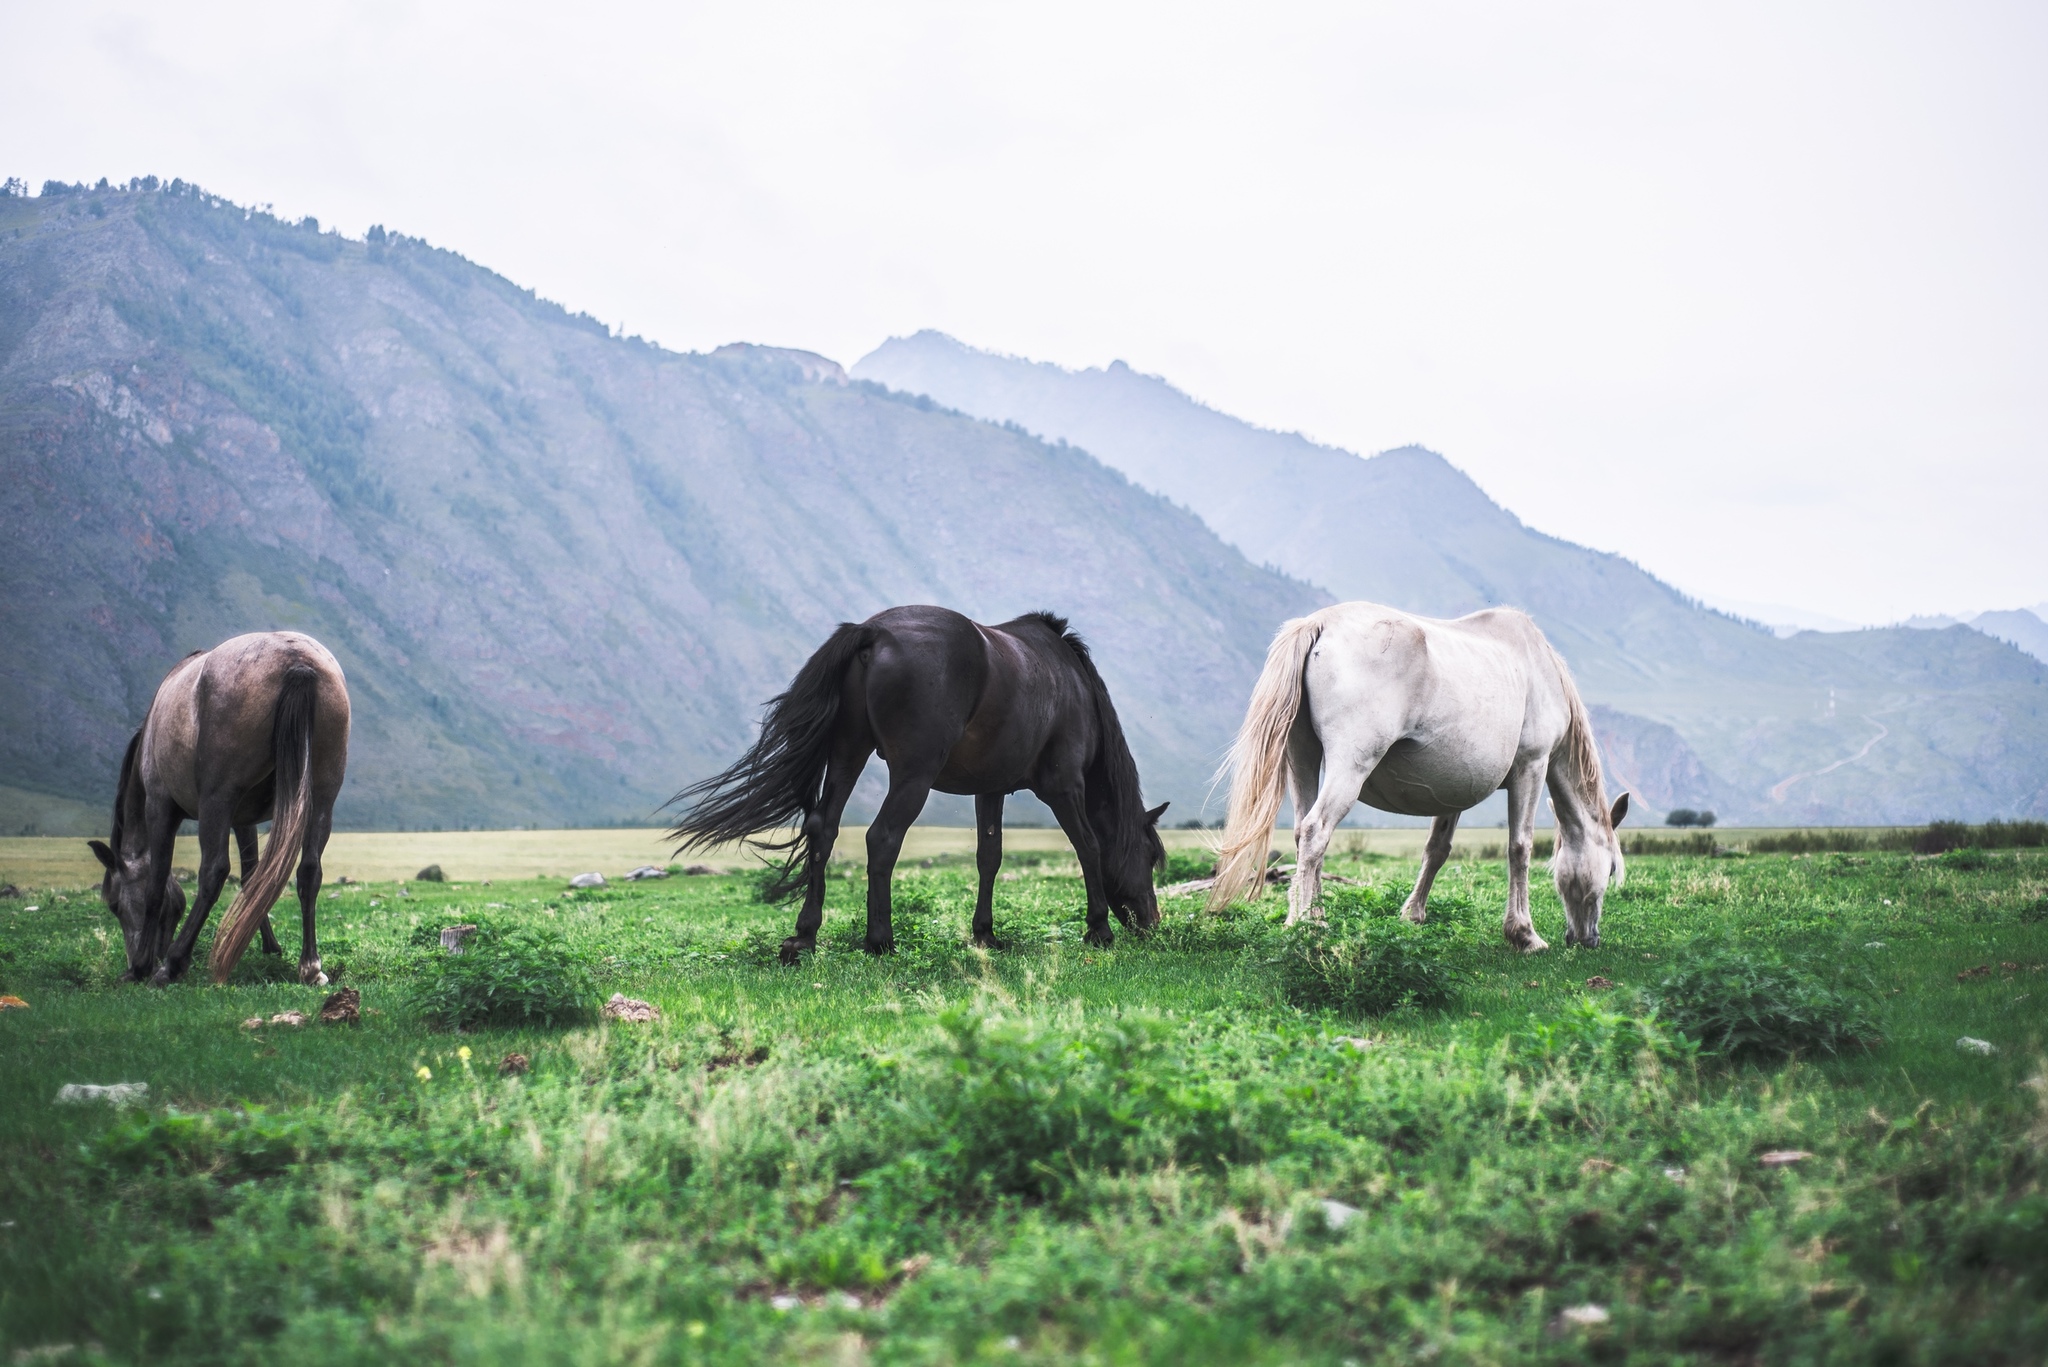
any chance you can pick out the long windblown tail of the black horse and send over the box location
[668,623,874,900]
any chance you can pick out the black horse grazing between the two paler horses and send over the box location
[672,607,1165,963]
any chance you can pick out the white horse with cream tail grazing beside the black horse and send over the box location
[1208,603,1628,953]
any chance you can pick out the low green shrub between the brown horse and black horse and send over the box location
[414,926,596,1029]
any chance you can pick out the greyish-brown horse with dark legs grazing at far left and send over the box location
[88,631,348,986]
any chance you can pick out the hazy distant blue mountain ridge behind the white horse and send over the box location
[852,332,2048,824]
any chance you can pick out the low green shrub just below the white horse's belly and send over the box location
[1280,916,1458,1017]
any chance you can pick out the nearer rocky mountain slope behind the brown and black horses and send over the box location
[0,182,1327,828]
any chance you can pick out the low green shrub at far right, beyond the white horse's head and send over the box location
[1642,945,1878,1060]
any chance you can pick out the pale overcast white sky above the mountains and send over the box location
[0,0,2048,623]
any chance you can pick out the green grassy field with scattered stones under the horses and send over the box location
[0,832,2048,1363]
